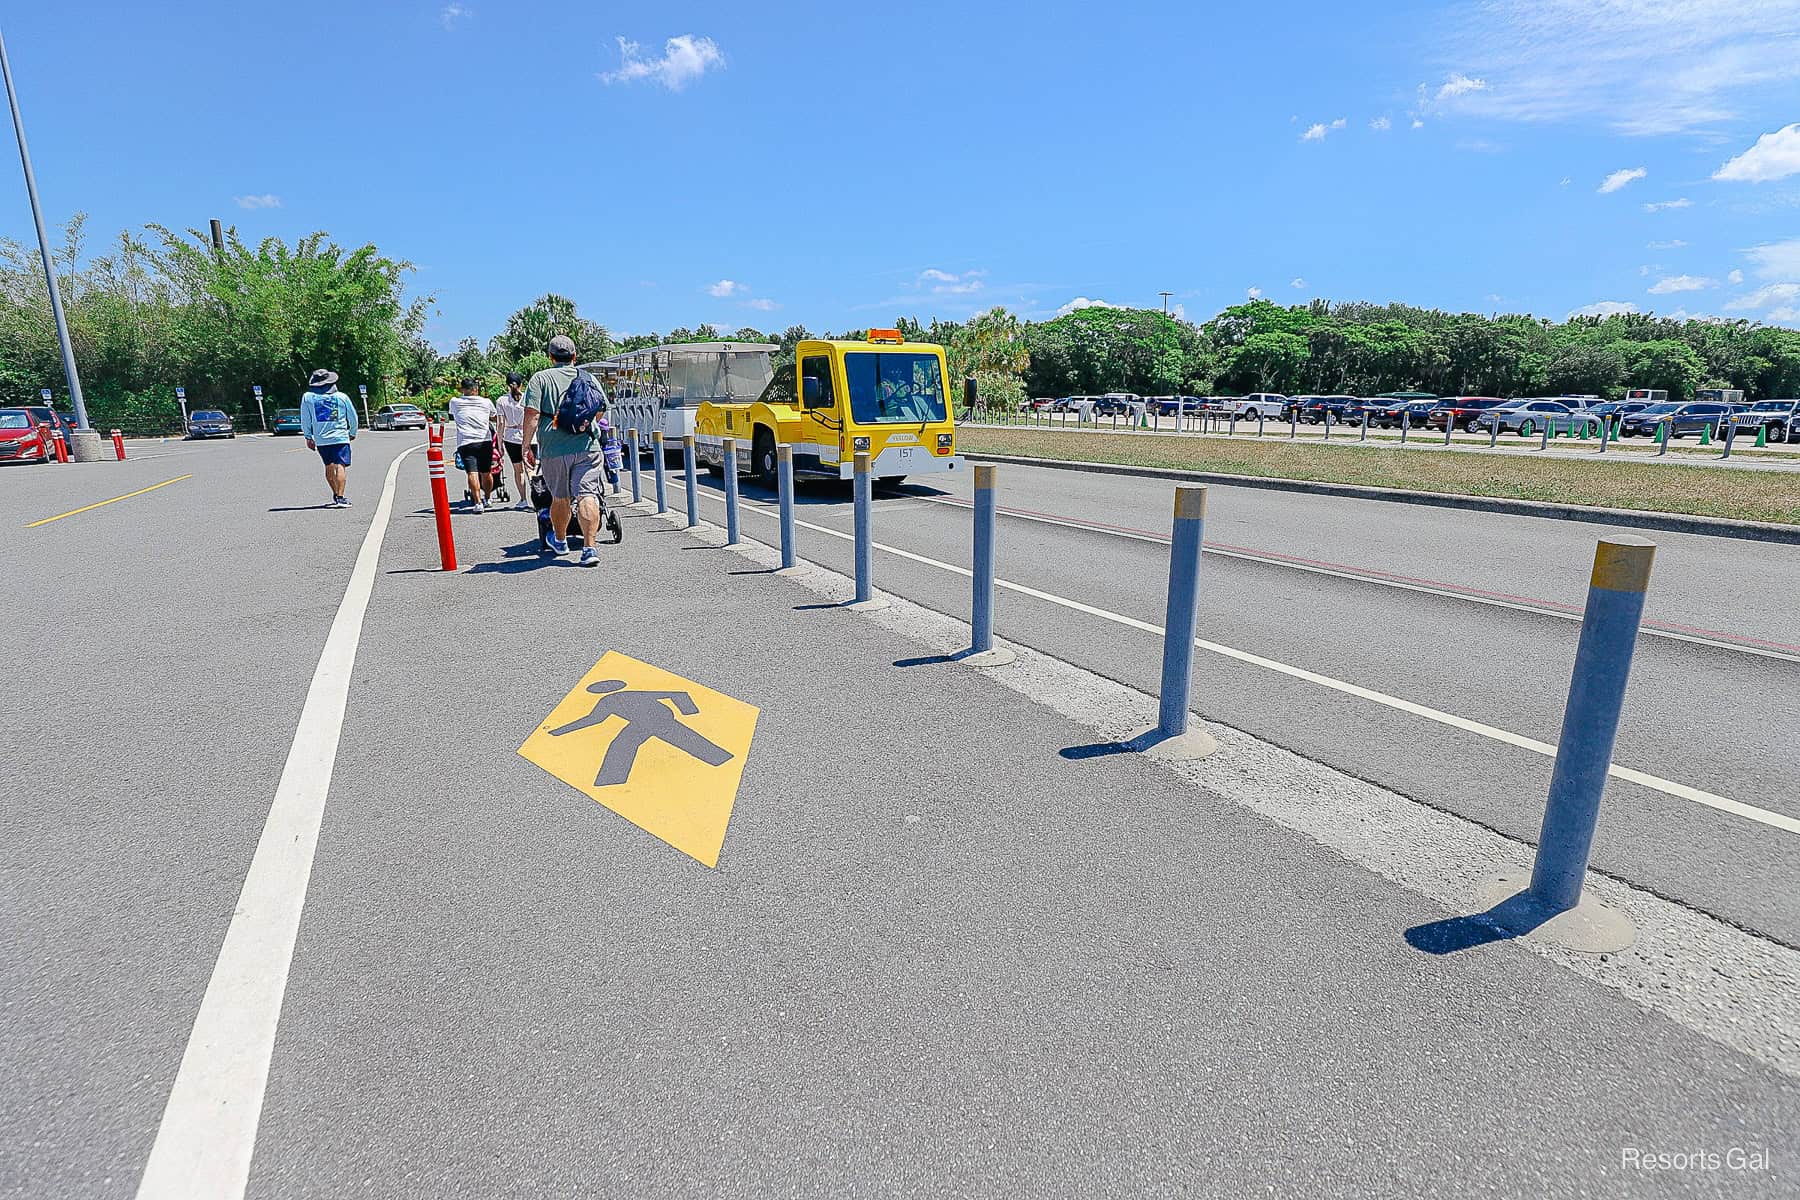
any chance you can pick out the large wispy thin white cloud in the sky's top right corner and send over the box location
[1440,0,1800,135]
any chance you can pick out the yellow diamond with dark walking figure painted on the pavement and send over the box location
[518,651,758,867]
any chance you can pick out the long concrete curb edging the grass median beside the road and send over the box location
[961,452,1800,545]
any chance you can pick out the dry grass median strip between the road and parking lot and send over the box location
[956,426,1800,525]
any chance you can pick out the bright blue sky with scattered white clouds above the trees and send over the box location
[0,0,1800,347]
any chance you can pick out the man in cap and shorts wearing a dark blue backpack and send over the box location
[524,335,607,567]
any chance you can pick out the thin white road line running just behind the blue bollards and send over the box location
[702,500,1800,833]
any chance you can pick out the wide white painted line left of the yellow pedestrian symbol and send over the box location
[137,446,421,1200]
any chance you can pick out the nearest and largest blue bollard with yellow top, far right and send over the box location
[1530,534,1656,912]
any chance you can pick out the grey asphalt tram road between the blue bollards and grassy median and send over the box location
[676,455,1800,946]
